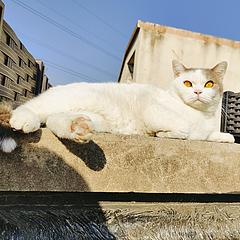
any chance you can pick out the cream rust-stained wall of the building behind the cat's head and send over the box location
[119,22,240,92]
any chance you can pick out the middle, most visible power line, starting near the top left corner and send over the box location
[12,0,121,61]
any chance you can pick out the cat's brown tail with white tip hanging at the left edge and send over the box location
[0,102,17,153]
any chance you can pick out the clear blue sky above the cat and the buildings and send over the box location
[4,0,240,85]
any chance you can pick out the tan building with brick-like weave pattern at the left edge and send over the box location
[0,1,50,105]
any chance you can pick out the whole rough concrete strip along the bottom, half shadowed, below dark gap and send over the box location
[0,202,240,240]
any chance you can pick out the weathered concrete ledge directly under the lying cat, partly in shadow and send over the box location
[0,129,240,193]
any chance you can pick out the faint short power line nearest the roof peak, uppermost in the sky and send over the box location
[37,0,117,47]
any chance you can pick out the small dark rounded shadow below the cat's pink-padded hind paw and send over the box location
[59,139,107,171]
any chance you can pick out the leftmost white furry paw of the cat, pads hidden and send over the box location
[9,107,40,133]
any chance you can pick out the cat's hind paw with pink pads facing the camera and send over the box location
[70,115,93,142]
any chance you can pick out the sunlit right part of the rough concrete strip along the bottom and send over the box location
[102,203,240,240]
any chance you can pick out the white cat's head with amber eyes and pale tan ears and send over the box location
[172,60,227,111]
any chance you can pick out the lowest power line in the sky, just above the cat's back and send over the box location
[21,32,115,77]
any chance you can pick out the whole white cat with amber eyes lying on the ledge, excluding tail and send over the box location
[7,60,234,149]
